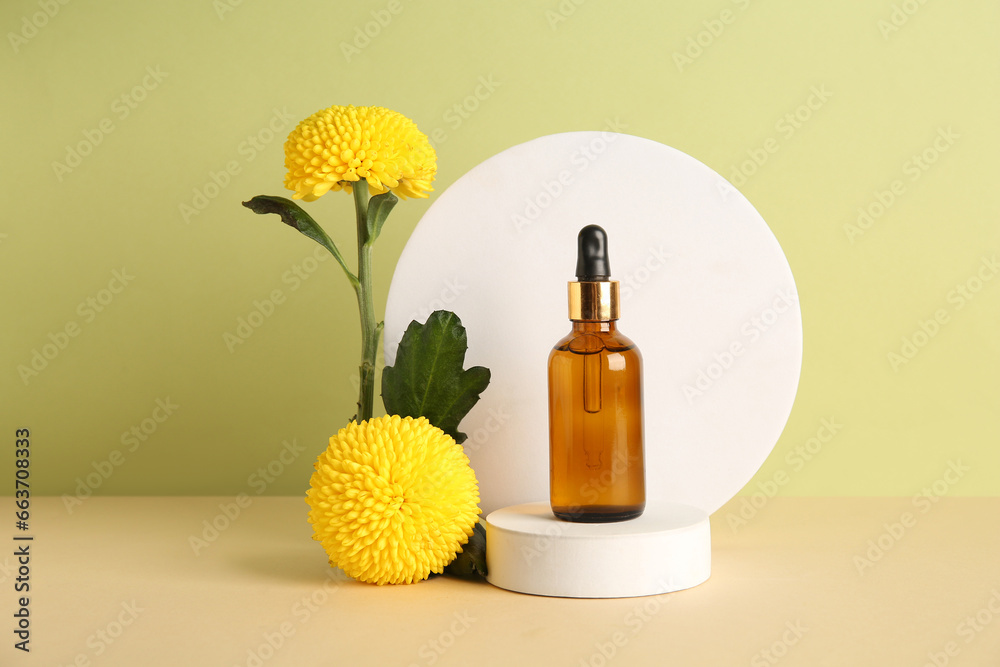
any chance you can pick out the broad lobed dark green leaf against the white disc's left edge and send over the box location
[382,310,490,443]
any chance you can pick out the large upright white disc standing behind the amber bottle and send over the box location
[385,132,802,513]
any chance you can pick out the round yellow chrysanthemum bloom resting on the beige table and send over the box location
[306,415,480,585]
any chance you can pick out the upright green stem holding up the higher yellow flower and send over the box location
[353,179,383,423]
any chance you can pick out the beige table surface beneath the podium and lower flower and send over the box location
[0,497,1000,667]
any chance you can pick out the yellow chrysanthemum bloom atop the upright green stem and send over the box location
[285,106,437,201]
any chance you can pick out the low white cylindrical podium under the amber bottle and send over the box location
[486,503,712,598]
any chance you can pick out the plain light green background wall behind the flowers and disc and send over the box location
[0,0,1000,496]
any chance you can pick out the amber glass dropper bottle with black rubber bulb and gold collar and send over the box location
[549,225,646,522]
